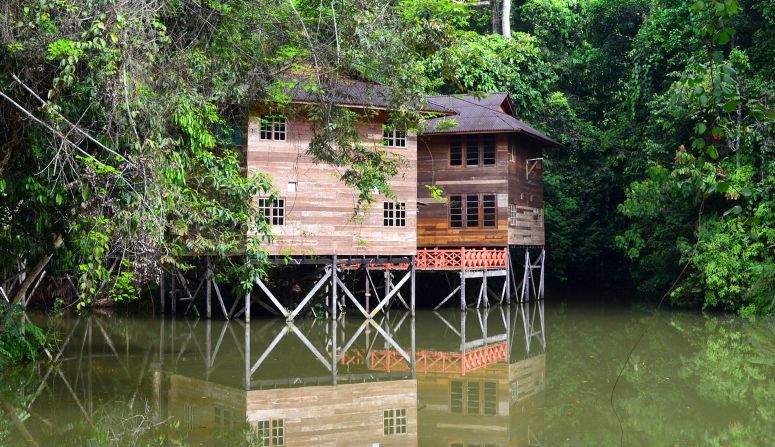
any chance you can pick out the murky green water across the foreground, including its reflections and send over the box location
[0,301,775,447]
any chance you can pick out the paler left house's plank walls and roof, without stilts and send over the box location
[247,81,448,258]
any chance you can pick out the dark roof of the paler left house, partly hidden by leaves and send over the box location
[287,80,453,114]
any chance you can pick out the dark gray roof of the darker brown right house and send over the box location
[421,93,562,147]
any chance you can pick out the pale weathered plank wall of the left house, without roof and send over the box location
[247,110,417,255]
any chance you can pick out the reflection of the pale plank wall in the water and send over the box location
[247,380,417,446]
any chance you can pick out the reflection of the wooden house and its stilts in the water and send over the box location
[162,303,545,447]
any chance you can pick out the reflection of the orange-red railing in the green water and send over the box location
[340,342,509,374]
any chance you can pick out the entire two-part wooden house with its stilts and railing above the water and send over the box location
[235,86,560,319]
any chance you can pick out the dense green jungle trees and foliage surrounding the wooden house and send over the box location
[0,0,775,314]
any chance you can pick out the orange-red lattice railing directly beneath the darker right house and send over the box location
[415,248,508,270]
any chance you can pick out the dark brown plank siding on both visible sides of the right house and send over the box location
[417,133,544,248]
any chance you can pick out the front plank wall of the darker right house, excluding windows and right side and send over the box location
[417,134,509,248]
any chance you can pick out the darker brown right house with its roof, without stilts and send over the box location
[417,93,561,248]
